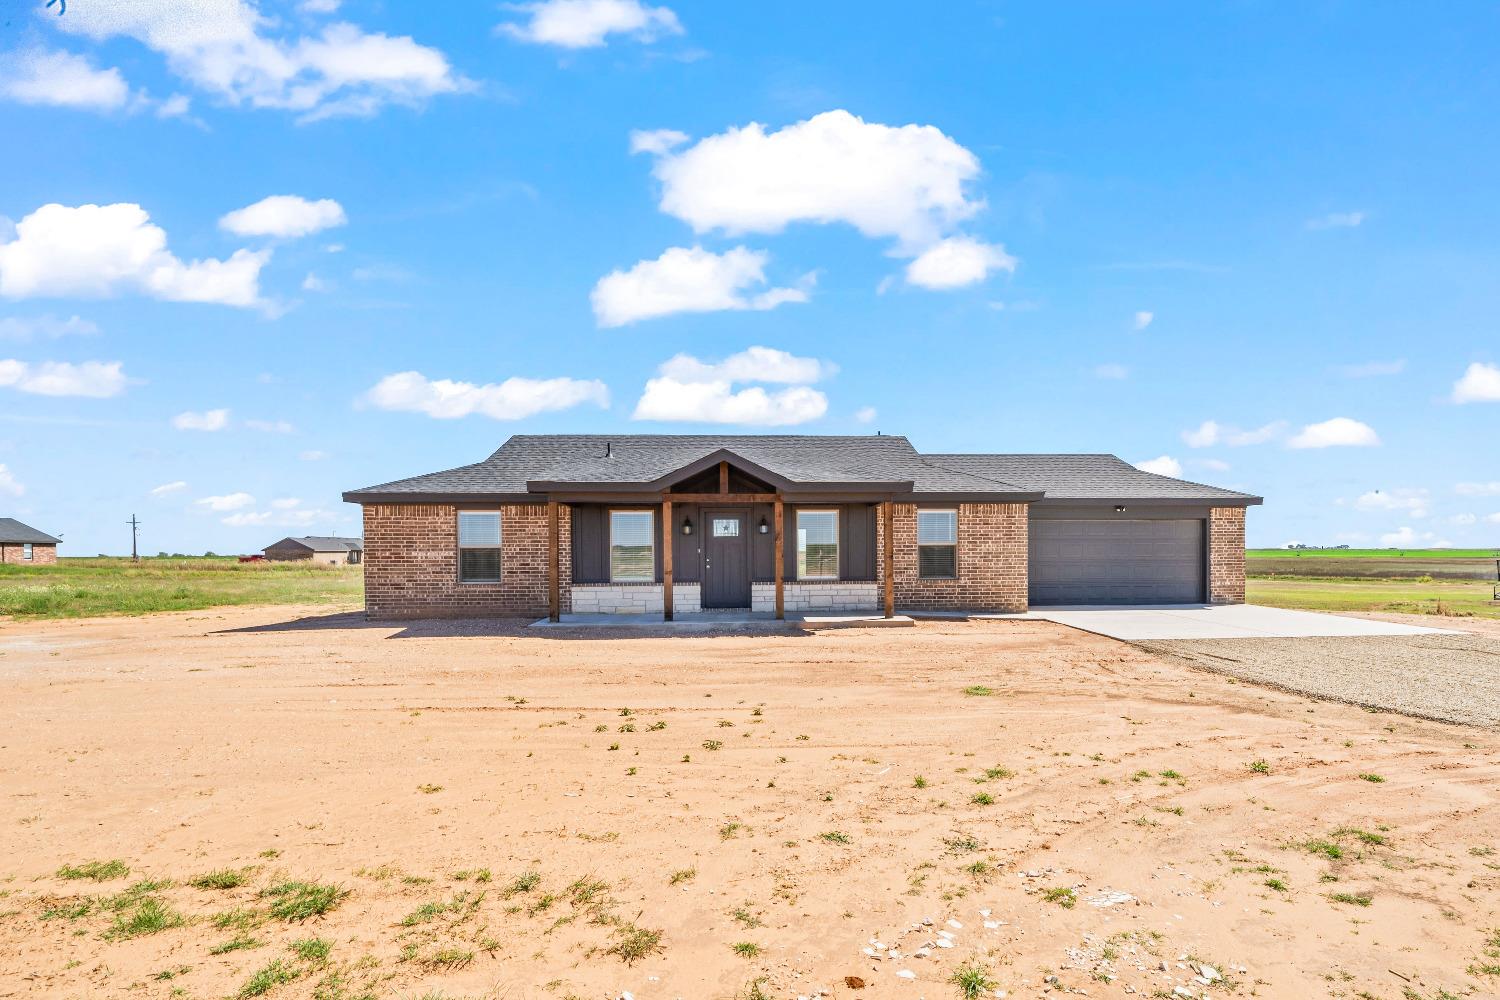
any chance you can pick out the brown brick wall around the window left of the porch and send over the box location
[365,504,573,618]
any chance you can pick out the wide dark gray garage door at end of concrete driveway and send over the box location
[1031,519,1203,604]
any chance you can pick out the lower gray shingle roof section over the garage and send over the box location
[926,454,1260,501]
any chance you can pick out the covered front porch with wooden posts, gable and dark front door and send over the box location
[540,450,911,625]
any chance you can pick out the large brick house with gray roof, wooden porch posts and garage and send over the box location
[344,435,1260,619]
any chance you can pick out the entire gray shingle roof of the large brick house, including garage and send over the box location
[344,435,1259,502]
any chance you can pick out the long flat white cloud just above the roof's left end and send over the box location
[363,372,609,420]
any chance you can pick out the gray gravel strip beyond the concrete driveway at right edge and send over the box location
[1136,634,1500,729]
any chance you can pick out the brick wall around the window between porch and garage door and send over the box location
[875,504,1029,612]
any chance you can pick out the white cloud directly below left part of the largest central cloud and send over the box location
[591,246,816,327]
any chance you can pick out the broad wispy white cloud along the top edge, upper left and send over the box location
[51,0,471,121]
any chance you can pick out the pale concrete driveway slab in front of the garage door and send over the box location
[1026,604,1455,642]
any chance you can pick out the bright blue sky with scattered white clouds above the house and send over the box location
[0,0,1500,555]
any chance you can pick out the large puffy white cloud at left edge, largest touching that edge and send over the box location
[0,202,270,306]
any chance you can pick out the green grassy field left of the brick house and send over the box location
[0,558,365,618]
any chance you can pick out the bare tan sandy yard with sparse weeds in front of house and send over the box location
[0,609,1500,1000]
